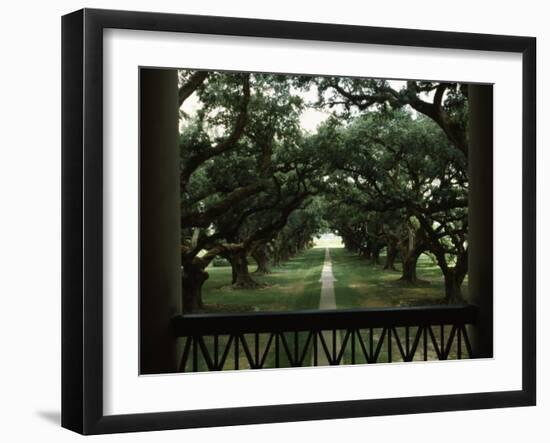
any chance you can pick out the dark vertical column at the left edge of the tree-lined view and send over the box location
[140,69,181,374]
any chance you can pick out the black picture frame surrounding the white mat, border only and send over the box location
[62,9,536,434]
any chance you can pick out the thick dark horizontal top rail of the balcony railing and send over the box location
[172,305,477,337]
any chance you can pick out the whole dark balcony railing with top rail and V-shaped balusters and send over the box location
[172,305,477,372]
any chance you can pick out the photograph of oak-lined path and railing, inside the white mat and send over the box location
[139,67,493,374]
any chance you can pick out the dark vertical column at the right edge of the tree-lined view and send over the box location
[468,85,493,357]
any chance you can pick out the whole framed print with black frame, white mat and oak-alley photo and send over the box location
[62,9,536,434]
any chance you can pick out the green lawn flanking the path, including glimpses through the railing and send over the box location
[187,246,467,371]
